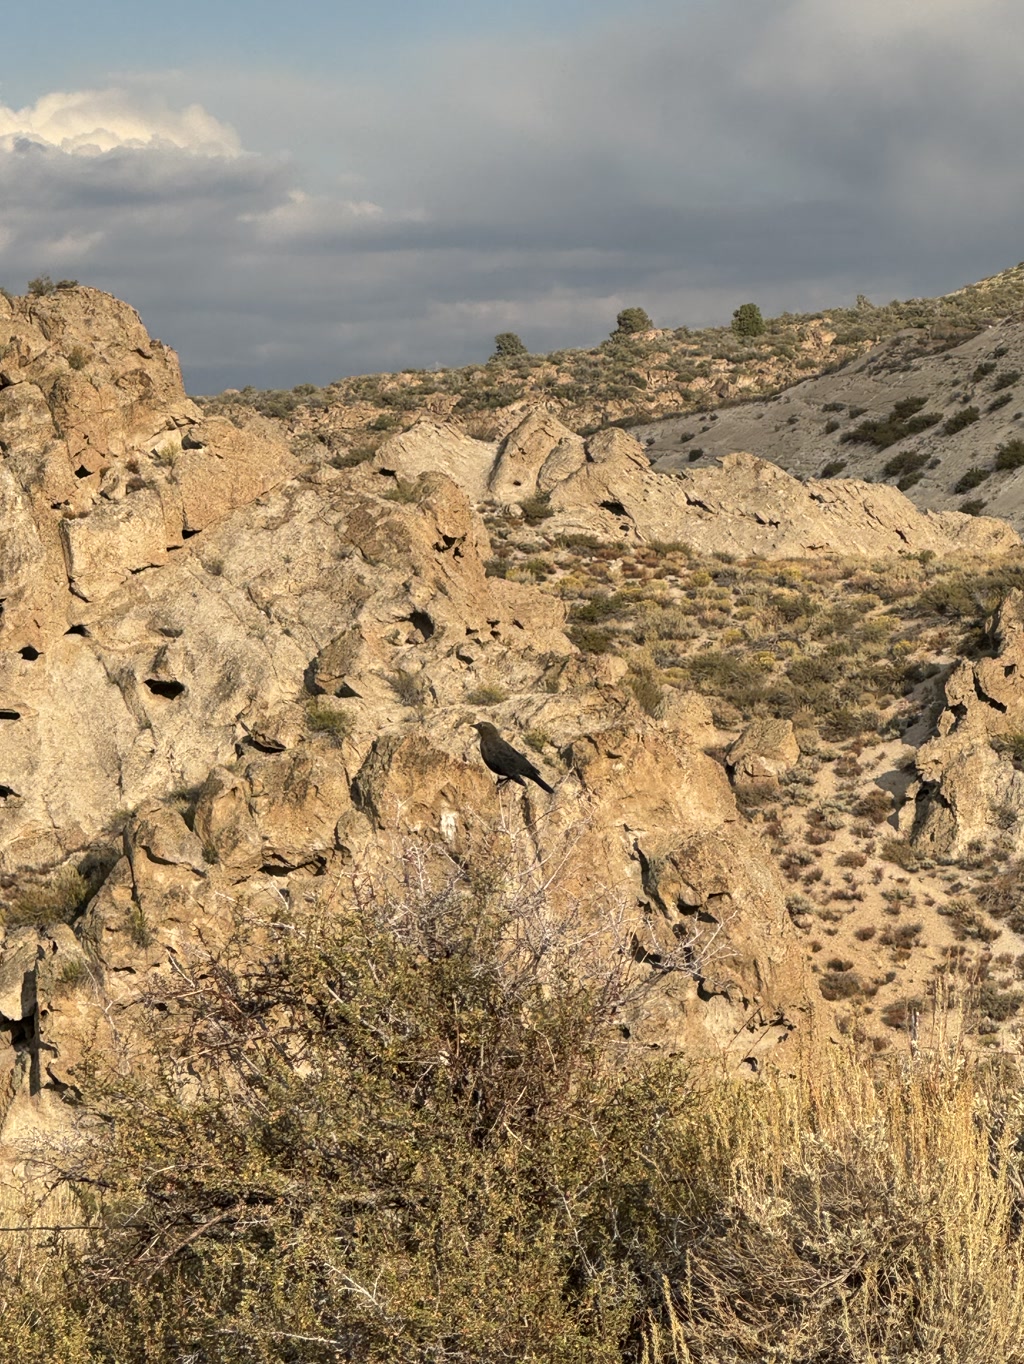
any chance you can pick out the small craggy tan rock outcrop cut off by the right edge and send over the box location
[900,589,1024,858]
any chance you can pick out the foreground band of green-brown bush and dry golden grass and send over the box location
[0,831,1024,1364]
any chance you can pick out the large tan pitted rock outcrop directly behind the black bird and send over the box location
[0,291,814,1178]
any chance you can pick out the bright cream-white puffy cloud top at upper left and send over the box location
[0,90,241,157]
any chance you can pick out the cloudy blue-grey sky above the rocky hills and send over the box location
[0,0,1024,393]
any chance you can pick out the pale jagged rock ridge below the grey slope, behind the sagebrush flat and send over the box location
[374,409,1020,558]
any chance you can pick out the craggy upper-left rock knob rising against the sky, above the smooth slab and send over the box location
[0,286,299,652]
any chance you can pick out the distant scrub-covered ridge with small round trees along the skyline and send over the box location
[199,265,1024,458]
